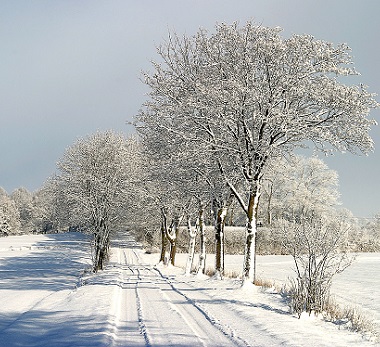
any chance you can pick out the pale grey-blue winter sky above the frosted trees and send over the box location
[0,0,380,217]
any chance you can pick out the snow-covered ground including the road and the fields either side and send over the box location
[0,233,380,347]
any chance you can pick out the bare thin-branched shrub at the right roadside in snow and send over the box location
[282,217,353,316]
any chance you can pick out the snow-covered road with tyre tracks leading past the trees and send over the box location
[107,248,242,346]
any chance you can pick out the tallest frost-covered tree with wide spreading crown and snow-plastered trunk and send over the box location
[138,22,378,282]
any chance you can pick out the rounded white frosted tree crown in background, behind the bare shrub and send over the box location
[260,155,339,224]
